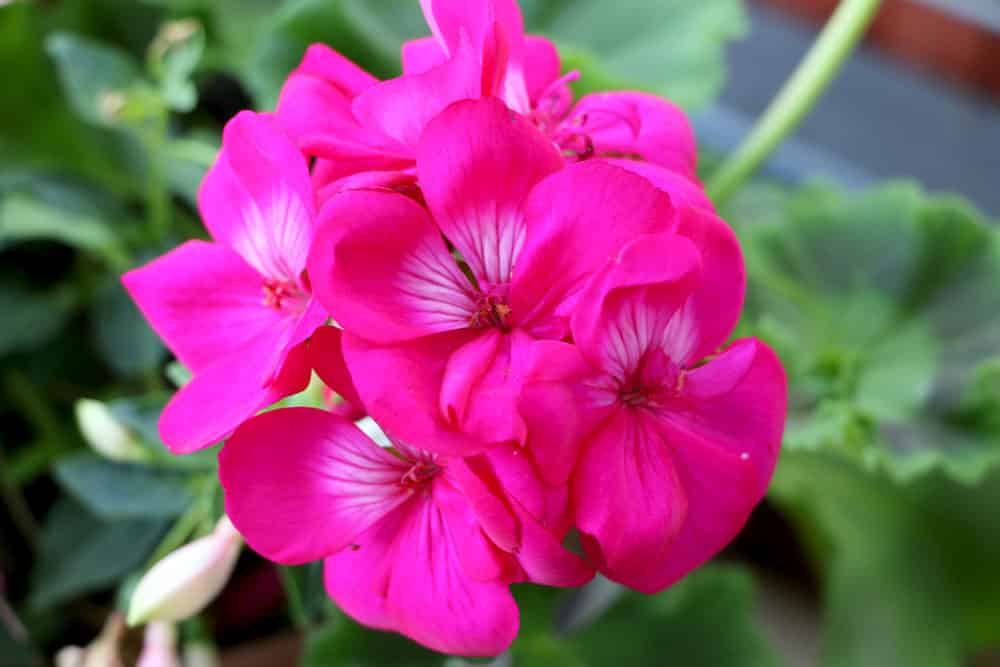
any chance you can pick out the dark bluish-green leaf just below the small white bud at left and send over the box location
[53,454,194,521]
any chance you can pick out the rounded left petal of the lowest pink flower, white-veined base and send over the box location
[219,408,410,564]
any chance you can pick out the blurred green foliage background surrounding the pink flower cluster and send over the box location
[0,0,1000,667]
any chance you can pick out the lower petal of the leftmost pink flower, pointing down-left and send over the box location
[160,335,310,454]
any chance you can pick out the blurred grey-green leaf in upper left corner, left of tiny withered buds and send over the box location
[45,32,141,124]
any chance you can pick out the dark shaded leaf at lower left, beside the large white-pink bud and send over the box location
[28,500,167,611]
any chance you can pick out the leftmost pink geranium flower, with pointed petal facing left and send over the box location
[122,112,327,453]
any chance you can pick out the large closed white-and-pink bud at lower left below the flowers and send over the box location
[128,516,243,625]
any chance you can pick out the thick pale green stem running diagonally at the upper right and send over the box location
[708,0,881,205]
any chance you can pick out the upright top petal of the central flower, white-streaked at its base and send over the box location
[417,99,563,290]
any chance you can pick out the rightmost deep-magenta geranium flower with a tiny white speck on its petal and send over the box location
[520,232,787,593]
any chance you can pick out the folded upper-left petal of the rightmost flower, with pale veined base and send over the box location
[571,234,701,379]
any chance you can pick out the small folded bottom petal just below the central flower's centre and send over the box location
[441,329,531,442]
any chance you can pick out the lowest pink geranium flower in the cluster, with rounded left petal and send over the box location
[219,408,593,656]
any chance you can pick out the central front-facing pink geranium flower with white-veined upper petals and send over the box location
[309,99,712,455]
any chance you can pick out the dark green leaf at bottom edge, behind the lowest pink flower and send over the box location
[302,565,780,667]
